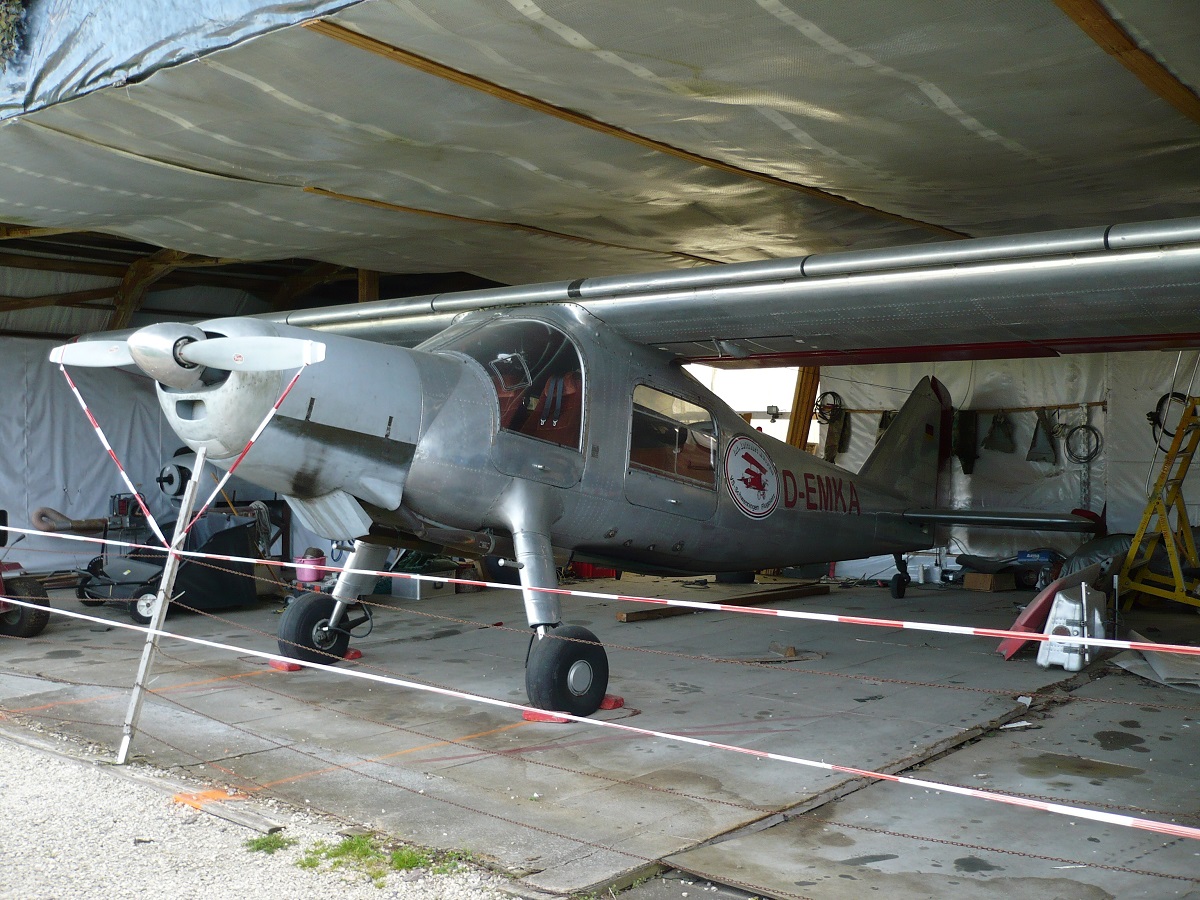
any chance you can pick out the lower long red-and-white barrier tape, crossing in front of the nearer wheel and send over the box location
[5,600,1200,840]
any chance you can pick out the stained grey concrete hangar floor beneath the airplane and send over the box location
[0,576,1200,900]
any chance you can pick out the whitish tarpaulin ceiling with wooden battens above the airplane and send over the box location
[0,0,1200,292]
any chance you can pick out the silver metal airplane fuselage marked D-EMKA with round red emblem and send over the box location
[158,305,932,571]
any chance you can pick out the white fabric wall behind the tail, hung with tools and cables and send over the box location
[821,352,1200,556]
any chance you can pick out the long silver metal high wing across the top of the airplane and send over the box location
[263,218,1200,366]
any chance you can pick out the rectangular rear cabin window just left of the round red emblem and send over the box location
[629,384,716,490]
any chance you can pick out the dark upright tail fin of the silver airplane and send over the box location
[858,376,953,508]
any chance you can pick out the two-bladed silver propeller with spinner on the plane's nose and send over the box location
[50,322,325,390]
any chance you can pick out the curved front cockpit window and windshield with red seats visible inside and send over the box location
[438,320,583,450]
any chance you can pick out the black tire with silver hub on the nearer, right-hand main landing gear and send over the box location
[526,625,608,715]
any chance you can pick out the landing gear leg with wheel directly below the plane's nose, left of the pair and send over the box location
[277,541,389,664]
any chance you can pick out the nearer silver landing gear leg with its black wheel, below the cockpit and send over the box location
[512,530,608,715]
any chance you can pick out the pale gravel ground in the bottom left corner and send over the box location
[0,736,512,900]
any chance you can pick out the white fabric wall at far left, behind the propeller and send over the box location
[0,338,180,571]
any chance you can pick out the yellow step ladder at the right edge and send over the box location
[1117,396,1200,610]
